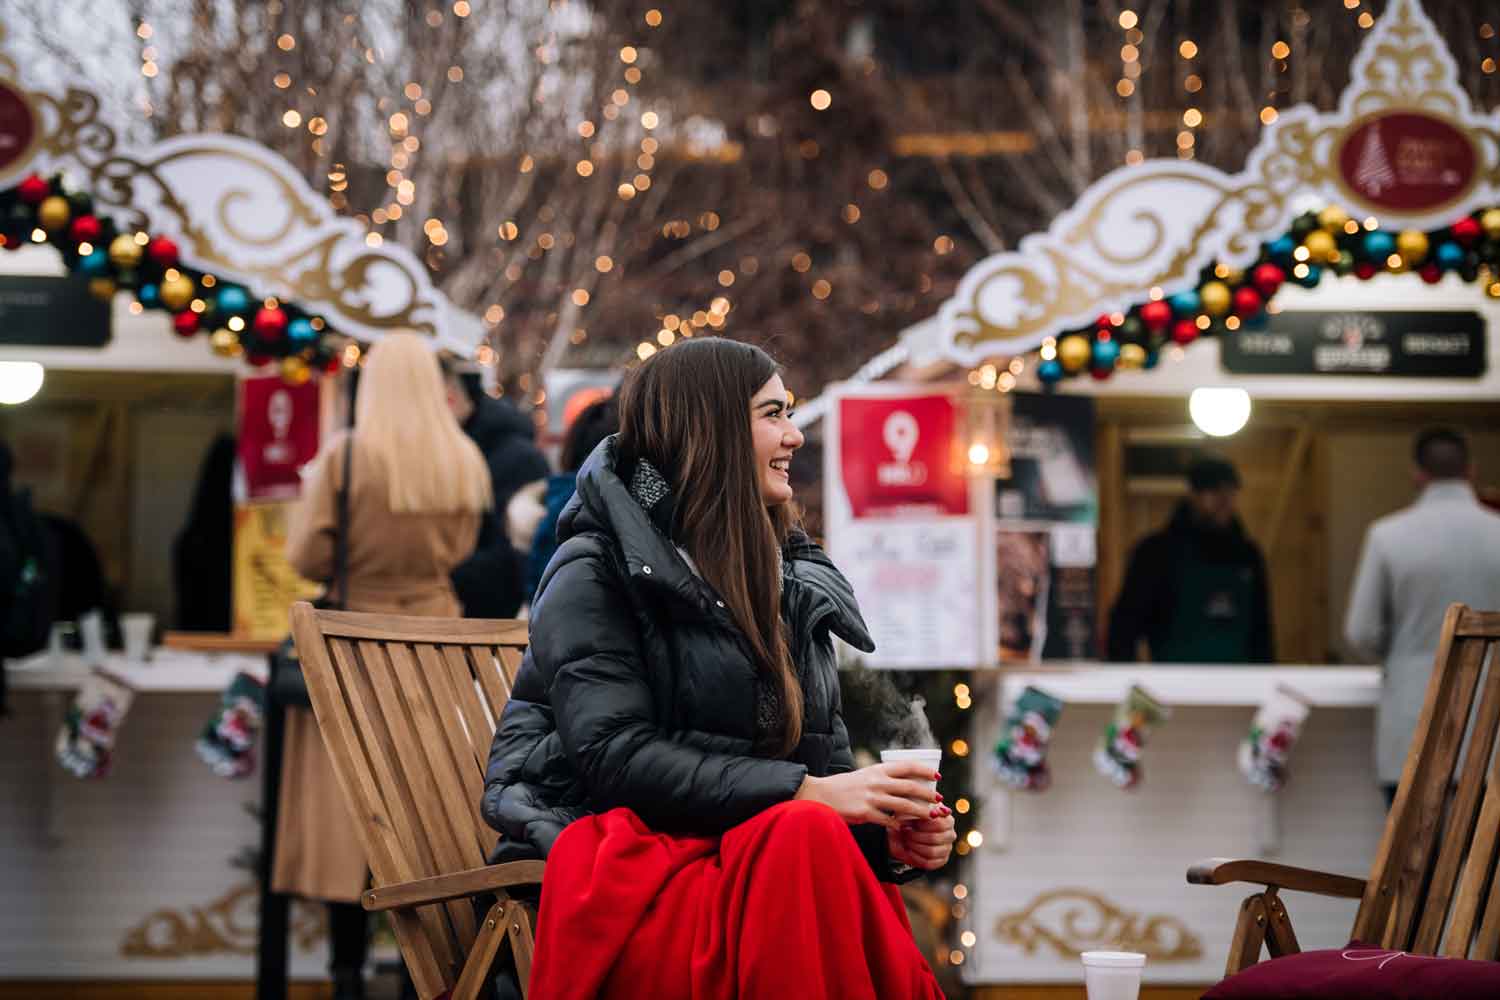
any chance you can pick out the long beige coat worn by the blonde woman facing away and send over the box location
[272,435,480,903]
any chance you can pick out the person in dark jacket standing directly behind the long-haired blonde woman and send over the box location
[444,363,551,618]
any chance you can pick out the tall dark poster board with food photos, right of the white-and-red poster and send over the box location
[995,393,1098,663]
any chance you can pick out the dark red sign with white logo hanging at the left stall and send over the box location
[239,375,318,499]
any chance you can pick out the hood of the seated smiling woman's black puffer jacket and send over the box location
[558,435,875,652]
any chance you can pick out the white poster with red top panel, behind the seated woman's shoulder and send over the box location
[824,385,993,670]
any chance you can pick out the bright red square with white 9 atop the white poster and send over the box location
[839,394,969,517]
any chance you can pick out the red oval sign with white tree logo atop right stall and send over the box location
[1338,111,1479,214]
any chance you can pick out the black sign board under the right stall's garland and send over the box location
[1220,309,1485,378]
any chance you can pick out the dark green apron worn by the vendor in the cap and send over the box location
[1151,550,1254,663]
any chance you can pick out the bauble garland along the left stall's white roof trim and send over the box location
[0,174,347,384]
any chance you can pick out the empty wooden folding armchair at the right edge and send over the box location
[1188,604,1500,976]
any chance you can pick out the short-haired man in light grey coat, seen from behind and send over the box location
[1344,429,1500,804]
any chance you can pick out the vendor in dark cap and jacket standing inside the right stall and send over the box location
[1109,459,1275,663]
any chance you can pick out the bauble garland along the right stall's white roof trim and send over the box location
[1037,205,1500,385]
